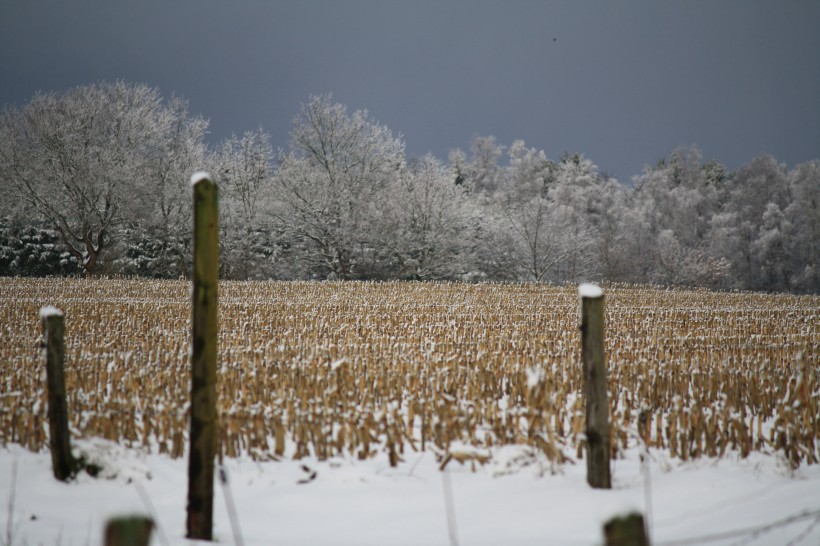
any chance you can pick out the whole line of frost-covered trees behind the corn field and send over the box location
[0,82,820,293]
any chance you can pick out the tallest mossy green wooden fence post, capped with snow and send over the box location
[187,173,219,540]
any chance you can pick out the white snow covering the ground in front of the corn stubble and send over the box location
[0,440,820,546]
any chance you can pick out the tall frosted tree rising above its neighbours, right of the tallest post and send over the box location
[274,96,405,279]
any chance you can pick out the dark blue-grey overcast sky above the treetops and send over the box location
[0,0,820,182]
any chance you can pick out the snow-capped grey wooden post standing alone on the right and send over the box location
[578,284,612,489]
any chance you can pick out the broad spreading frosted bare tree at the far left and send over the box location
[0,82,204,275]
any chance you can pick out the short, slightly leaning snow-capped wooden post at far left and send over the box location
[40,307,77,481]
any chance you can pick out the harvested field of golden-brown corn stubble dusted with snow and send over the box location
[0,278,820,466]
